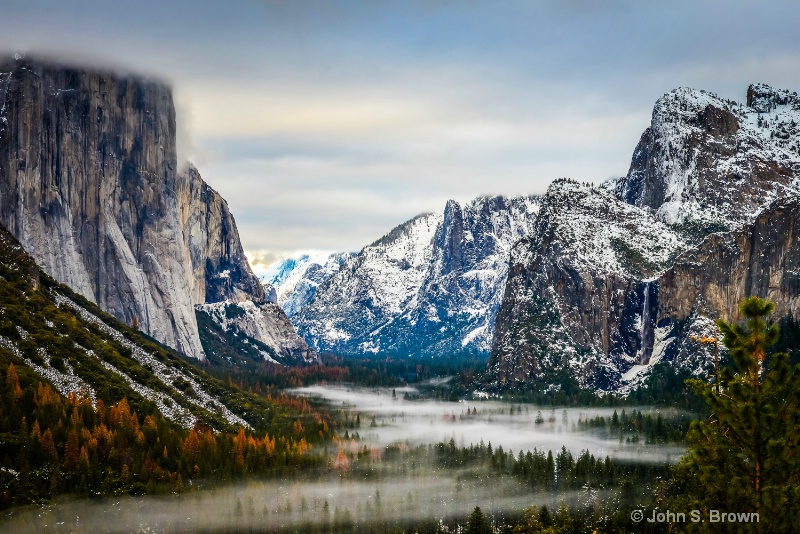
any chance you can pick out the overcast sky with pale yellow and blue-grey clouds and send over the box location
[0,0,800,272]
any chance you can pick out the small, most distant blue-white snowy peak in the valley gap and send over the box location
[259,252,356,317]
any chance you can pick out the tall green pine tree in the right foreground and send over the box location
[677,297,800,532]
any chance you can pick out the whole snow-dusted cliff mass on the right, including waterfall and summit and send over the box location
[486,85,800,391]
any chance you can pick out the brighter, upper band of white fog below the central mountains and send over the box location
[292,386,684,463]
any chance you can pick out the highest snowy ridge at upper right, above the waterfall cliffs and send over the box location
[617,85,800,229]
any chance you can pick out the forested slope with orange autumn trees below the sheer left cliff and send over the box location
[0,228,333,509]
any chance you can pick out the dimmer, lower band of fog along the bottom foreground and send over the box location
[0,471,588,534]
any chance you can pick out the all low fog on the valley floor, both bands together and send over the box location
[0,386,683,534]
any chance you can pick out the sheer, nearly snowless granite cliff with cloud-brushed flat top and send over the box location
[0,59,318,359]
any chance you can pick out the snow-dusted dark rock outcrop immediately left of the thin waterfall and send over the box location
[488,179,688,388]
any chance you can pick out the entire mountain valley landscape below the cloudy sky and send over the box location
[0,51,800,533]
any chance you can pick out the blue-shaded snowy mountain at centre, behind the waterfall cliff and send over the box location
[293,197,538,357]
